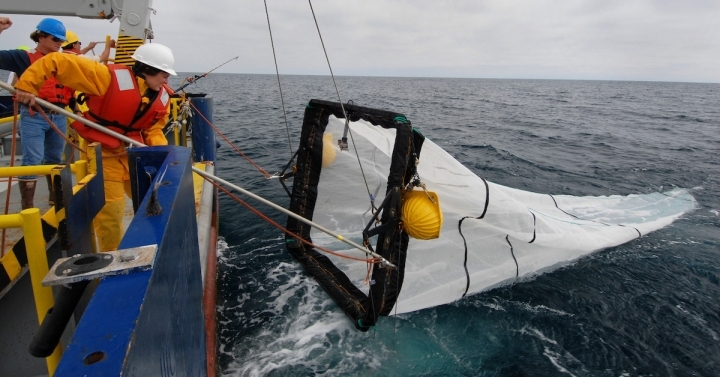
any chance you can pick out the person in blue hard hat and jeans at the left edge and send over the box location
[0,18,76,209]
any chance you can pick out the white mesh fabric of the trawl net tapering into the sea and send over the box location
[311,116,696,314]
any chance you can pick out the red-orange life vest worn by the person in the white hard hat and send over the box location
[70,64,170,148]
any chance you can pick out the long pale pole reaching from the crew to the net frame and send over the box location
[0,82,397,268]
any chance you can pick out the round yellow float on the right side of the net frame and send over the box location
[402,190,443,240]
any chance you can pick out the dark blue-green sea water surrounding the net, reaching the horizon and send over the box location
[174,74,720,376]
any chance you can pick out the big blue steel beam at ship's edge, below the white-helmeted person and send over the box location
[56,143,214,376]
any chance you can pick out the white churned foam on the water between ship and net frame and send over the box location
[221,262,380,376]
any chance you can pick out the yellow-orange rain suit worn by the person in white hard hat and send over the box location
[15,54,170,251]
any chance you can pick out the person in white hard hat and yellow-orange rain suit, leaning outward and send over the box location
[15,43,176,251]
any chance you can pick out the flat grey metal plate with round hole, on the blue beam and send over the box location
[42,245,157,287]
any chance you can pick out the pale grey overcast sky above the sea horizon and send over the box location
[0,0,720,83]
